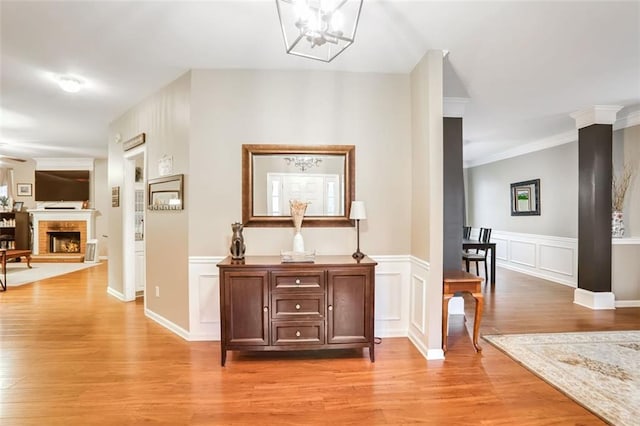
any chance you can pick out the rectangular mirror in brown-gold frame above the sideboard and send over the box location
[242,145,355,227]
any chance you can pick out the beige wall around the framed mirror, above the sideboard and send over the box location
[188,70,411,256]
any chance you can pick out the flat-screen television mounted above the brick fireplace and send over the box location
[35,170,89,201]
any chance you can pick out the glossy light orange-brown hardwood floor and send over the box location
[0,264,640,426]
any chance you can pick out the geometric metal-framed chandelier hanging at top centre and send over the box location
[276,0,362,62]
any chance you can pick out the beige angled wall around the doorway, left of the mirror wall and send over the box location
[107,73,193,330]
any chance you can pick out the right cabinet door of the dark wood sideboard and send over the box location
[327,268,373,343]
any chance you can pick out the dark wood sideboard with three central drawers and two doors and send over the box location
[218,256,377,366]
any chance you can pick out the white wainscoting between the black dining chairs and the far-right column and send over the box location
[491,230,578,287]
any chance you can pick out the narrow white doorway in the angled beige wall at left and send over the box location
[122,145,146,307]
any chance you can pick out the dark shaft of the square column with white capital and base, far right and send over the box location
[578,124,613,292]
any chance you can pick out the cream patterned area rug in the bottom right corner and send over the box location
[484,331,640,426]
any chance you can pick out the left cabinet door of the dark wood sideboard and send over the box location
[223,271,269,346]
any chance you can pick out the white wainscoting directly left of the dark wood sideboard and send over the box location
[188,256,224,340]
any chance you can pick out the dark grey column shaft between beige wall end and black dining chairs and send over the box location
[442,117,464,269]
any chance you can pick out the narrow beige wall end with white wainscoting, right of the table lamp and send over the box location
[410,50,443,351]
